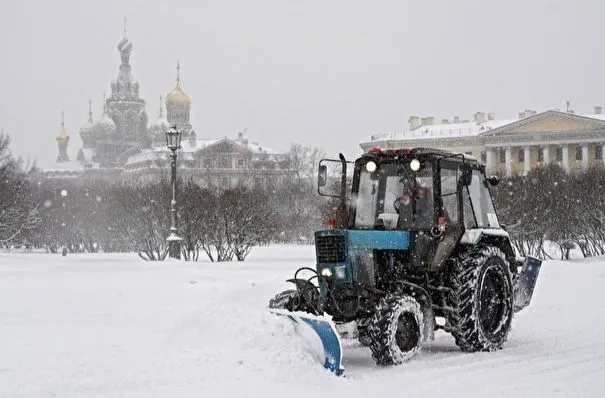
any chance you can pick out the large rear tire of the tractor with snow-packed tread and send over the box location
[447,245,513,352]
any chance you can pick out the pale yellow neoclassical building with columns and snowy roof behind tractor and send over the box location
[360,110,605,174]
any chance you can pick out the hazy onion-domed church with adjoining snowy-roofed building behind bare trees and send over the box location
[33,23,291,187]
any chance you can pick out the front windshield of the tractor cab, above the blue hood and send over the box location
[352,163,434,229]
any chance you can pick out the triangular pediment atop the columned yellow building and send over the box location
[484,111,605,136]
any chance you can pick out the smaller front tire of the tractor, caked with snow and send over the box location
[368,295,425,366]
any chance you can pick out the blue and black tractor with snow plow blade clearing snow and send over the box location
[269,148,541,373]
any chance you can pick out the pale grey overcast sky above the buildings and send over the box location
[0,0,605,166]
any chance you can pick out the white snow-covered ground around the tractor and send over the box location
[0,246,605,398]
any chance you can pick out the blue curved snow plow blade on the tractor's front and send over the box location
[269,309,344,376]
